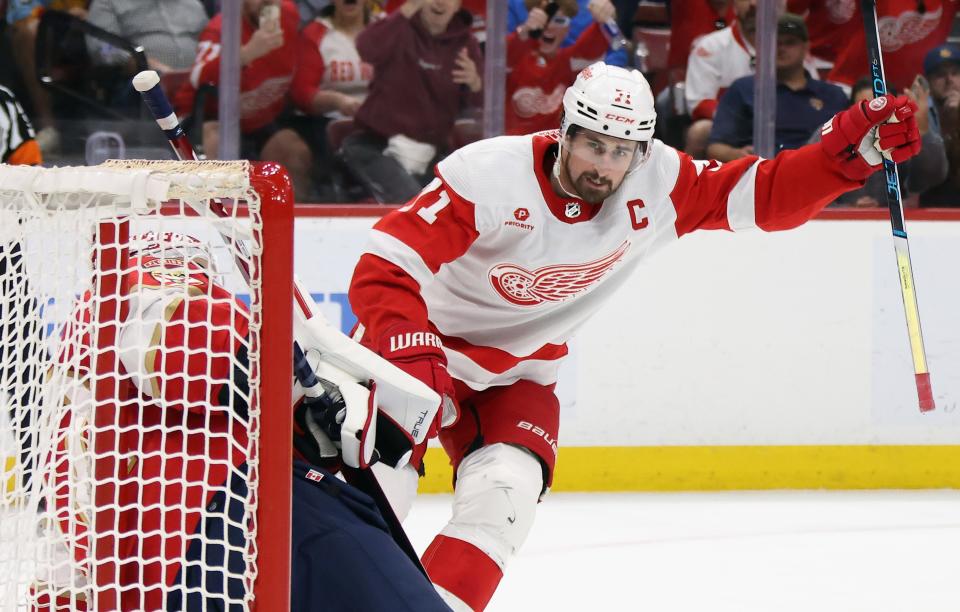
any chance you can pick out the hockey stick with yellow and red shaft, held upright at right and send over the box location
[860,0,936,412]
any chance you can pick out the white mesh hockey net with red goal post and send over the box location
[0,160,293,611]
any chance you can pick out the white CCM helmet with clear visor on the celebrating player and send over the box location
[553,62,657,197]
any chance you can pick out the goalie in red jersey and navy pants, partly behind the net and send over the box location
[29,232,448,611]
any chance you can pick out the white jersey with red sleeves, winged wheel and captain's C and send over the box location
[350,132,859,389]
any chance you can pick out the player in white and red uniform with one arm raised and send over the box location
[350,63,919,610]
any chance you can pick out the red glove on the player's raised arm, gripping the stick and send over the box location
[820,95,920,181]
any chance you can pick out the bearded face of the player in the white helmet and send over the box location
[564,130,637,203]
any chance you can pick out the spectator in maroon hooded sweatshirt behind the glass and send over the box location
[342,0,483,202]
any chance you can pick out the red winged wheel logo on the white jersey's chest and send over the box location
[490,242,630,306]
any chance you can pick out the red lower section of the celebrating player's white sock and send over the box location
[423,535,503,612]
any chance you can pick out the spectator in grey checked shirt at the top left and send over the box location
[87,0,208,73]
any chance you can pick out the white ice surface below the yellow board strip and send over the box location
[405,491,960,612]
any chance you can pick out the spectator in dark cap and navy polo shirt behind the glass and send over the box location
[707,13,849,162]
